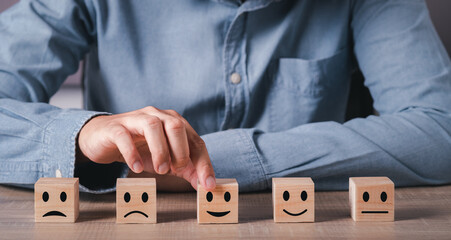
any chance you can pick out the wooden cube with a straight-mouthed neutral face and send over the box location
[349,177,395,221]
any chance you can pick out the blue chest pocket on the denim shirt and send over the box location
[268,49,350,131]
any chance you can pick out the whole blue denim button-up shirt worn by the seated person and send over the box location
[0,0,451,192]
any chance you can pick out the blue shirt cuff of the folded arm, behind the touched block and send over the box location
[202,129,269,192]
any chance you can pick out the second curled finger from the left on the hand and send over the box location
[142,115,170,174]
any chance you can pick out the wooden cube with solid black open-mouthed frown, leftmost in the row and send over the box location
[34,178,79,222]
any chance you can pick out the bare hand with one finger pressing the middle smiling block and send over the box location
[78,107,216,189]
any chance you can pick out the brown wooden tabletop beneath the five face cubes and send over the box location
[0,186,451,240]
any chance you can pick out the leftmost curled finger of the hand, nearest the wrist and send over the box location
[110,126,143,173]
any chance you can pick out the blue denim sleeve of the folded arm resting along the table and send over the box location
[203,0,451,191]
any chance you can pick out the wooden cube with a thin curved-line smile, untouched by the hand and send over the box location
[272,177,315,222]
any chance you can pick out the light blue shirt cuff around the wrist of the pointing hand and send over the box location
[41,109,128,193]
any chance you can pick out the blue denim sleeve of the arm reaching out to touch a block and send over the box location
[0,0,126,192]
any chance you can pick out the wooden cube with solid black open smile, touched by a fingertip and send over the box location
[197,178,238,223]
